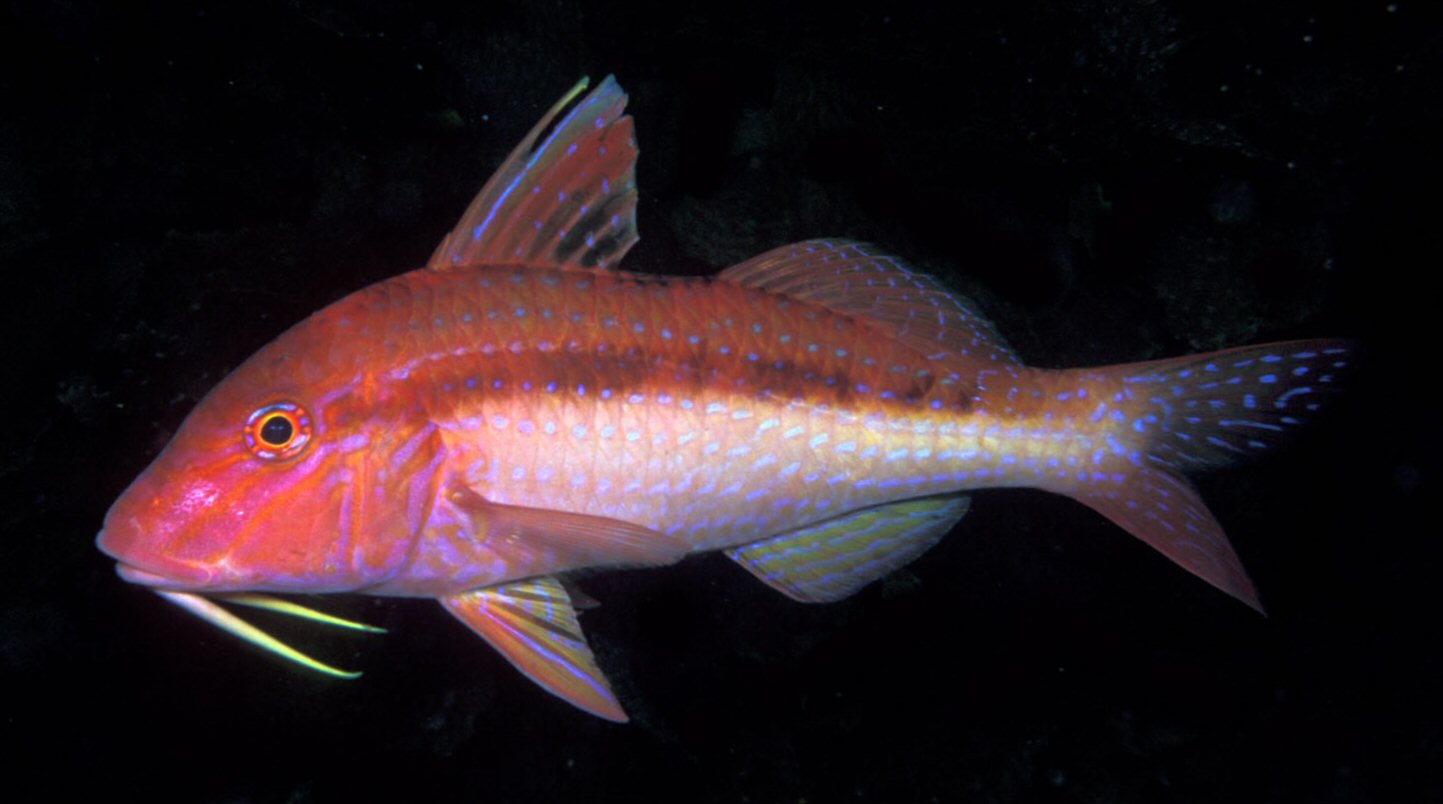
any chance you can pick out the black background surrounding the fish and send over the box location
[0,0,1443,803]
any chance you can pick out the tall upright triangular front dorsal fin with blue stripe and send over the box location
[427,77,636,271]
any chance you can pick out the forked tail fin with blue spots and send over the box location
[1072,341,1355,612]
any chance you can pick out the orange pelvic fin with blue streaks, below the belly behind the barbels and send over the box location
[440,577,626,723]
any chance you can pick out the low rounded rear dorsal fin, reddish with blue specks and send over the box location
[719,240,1022,383]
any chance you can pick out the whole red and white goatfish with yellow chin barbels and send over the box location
[97,77,1356,722]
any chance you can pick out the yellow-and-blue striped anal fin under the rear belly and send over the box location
[726,495,971,603]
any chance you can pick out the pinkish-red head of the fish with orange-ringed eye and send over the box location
[97,316,434,593]
